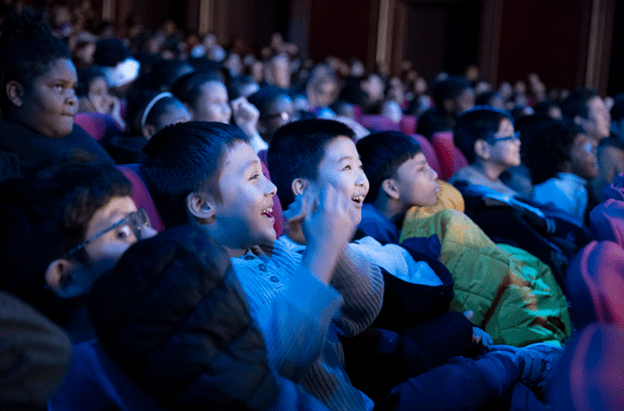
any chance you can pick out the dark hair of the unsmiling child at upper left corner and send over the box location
[0,7,71,114]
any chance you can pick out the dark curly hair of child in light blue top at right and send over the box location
[525,119,579,184]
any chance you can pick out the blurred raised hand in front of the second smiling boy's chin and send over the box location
[284,184,361,283]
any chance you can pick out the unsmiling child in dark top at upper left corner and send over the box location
[0,8,114,171]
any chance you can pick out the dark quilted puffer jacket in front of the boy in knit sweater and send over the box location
[89,227,279,410]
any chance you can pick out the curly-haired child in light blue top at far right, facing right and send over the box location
[526,120,598,225]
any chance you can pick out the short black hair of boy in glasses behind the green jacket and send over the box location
[454,106,514,164]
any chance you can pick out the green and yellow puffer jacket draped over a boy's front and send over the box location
[399,210,572,347]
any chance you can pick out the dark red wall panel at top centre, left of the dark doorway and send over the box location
[309,0,377,62]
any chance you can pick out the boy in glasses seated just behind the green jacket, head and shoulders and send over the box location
[449,106,520,196]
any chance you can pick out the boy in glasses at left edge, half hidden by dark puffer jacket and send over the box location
[0,162,156,344]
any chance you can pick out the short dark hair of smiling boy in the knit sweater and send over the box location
[141,121,249,227]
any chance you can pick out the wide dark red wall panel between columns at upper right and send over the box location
[498,0,584,88]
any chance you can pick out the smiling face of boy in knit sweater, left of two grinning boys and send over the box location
[214,143,277,249]
